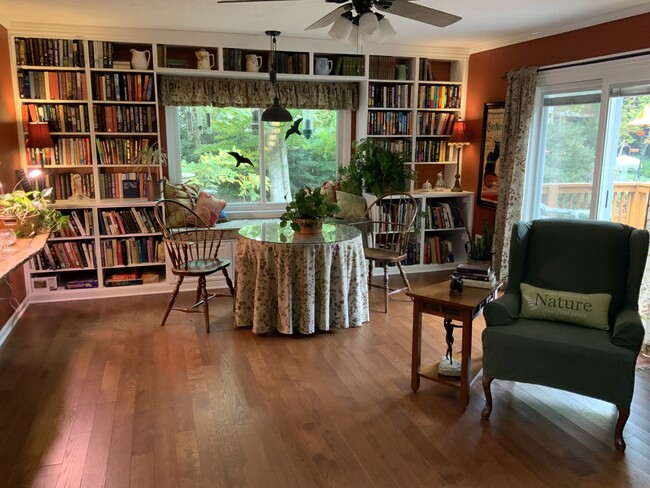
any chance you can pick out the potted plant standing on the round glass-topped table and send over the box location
[280,186,339,234]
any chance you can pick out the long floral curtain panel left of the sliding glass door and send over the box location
[494,67,537,281]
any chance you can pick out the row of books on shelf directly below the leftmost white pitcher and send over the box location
[93,73,154,102]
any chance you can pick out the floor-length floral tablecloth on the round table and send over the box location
[235,222,369,334]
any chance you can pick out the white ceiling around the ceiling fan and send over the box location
[0,0,650,52]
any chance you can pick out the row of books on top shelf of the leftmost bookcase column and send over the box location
[15,37,84,68]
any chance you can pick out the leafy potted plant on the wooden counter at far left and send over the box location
[0,190,68,237]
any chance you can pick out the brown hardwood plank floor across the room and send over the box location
[0,275,650,488]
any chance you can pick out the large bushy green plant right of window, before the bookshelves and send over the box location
[339,138,415,197]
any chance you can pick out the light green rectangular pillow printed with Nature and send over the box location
[519,283,612,330]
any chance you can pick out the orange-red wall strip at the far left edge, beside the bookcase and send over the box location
[0,21,25,329]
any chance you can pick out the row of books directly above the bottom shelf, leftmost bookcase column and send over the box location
[31,241,97,271]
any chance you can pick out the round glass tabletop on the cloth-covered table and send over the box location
[239,220,361,245]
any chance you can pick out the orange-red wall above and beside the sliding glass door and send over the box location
[462,14,650,233]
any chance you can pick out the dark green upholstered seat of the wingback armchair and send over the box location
[482,318,636,406]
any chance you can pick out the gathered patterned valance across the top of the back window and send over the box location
[158,75,359,110]
